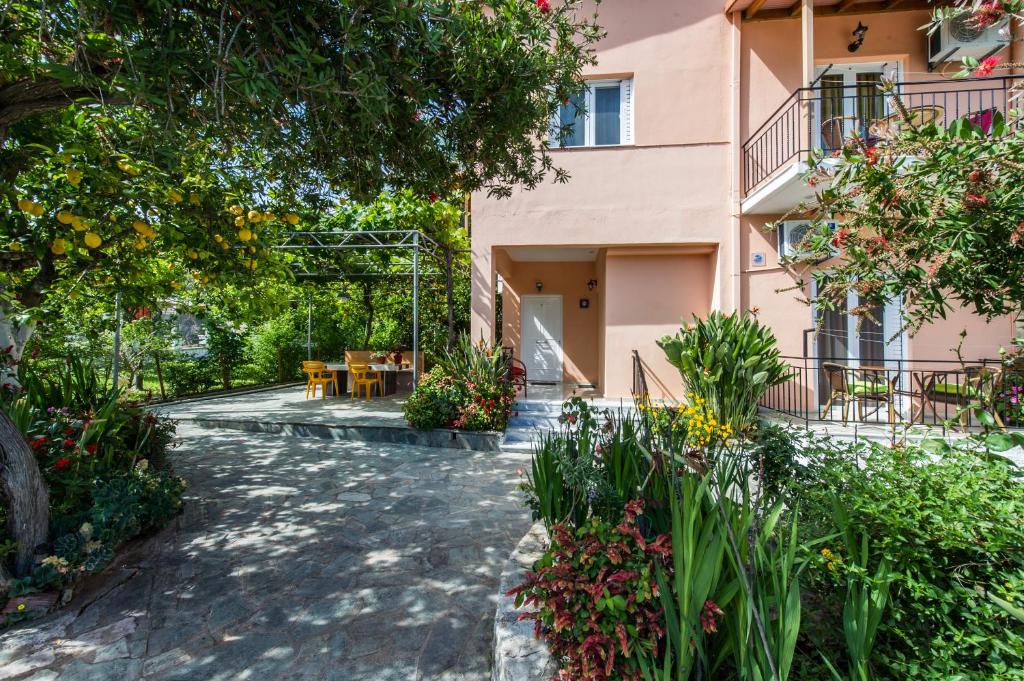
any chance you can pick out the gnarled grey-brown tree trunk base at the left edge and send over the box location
[0,411,50,577]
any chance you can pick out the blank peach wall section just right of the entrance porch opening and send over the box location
[603,253,715,400]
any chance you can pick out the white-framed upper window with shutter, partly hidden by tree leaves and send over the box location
[551,79,633,146]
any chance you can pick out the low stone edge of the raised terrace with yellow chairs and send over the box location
[186,417,502,453]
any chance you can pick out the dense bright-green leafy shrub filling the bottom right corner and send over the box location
[800,440,1024,679]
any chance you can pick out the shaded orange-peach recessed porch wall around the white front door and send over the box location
[499,262,601,385]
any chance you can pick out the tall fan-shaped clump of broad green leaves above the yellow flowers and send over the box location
[657,311,792,431]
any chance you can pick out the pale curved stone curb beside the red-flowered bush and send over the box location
[490,522,558,681]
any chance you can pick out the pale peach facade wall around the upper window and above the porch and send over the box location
[472,0,735,348]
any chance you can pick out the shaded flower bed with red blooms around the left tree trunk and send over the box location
[0,361,185,624]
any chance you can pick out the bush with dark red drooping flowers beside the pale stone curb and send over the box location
[509,501,672,681]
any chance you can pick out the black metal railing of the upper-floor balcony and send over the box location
[742,76,1024,195]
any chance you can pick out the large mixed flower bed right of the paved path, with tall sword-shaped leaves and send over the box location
[516,315,1024,681]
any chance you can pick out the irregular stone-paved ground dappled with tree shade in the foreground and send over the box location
[0,427,530,681]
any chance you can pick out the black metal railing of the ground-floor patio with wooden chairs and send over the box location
[761,356,1024,428]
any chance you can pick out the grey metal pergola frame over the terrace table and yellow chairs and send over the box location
[271,229,453,376]
